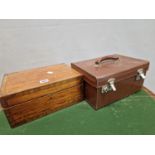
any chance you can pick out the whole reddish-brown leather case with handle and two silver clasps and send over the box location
[71,54,149,109]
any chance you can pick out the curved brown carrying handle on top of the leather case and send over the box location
[95,55,119,65]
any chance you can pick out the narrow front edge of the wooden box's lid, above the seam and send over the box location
[2,77,83,108]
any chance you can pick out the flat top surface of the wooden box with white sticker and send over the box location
[0,64,81,97]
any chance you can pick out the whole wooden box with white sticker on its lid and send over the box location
[0,64,83,127]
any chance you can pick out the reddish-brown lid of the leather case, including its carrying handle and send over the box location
[71,54,149,87]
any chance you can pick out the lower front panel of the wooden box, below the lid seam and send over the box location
[5,84,84,127]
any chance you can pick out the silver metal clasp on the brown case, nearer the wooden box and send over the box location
[101,78,116,93]
